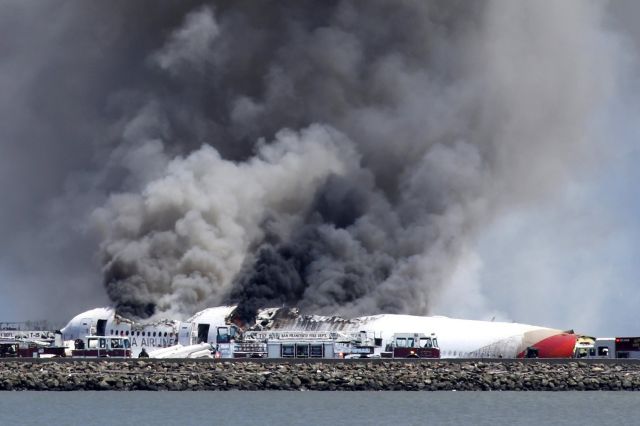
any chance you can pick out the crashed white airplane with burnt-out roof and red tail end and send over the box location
[61,306,577,358]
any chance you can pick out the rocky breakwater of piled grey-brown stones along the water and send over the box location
[0,360,640,391]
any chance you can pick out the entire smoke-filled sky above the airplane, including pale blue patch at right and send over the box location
[0,0,640,334]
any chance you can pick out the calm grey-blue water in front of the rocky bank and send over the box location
[0,391,640,426]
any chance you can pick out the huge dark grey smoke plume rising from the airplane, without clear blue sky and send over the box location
[0,0,614,319]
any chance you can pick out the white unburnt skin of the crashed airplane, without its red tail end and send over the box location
[61,306,561,358]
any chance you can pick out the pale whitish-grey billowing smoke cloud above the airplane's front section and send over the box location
[94,126,357,315]
